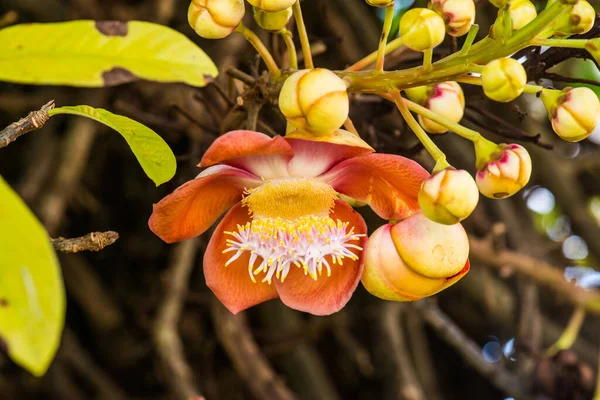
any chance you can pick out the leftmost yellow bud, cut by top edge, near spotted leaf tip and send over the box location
[188,0,245,39]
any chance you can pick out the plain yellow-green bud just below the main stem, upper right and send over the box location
[481,58,527,103]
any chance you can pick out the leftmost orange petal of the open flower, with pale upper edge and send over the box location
[148,165,262,243]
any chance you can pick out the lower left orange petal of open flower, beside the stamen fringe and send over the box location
[203,203,277,314]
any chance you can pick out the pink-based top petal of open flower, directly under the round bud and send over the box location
[286,138,373,178]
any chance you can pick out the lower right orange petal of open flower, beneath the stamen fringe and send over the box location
[275,200,367,315]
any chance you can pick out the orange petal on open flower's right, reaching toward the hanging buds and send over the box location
[321,154,429,220]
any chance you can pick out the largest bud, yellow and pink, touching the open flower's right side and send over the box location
[362,213,469,301]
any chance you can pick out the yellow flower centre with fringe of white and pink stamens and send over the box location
[223,178,365,284]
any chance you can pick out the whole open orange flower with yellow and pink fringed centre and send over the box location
[149,131,428,315]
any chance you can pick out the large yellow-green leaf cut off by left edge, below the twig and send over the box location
[0,177,65,376]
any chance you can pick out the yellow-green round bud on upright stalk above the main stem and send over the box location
[400,8,446,51]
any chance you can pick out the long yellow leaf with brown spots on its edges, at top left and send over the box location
[0,21,218,87]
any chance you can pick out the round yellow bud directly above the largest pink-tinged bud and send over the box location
[419,168,479,225]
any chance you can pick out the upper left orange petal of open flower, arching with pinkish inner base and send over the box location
[200,131,294,179]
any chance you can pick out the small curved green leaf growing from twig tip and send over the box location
[48,106,177,186]
